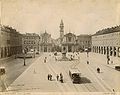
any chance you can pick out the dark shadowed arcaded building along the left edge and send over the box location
[0,26,22,58]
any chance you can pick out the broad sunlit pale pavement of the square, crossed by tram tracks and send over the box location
[7,53,120,92]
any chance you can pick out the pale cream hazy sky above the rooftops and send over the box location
[0,0,120,38]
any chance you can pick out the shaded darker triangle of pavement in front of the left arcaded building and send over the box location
[0,56,38,91]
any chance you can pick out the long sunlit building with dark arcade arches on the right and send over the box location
[92,26,120,57]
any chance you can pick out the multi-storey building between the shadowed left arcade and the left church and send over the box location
[22,33,40,52]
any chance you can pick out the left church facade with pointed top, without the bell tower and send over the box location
[39,31,54,52]
